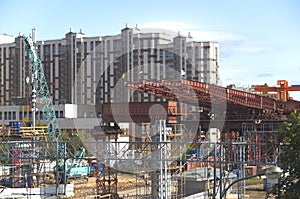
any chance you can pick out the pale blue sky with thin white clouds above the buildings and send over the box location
[0,0,300,100]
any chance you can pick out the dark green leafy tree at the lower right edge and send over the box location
[272,113,300,199]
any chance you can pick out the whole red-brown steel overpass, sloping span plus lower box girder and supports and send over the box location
[99,80,300,164]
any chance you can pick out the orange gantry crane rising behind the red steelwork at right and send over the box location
[254,80,300,102]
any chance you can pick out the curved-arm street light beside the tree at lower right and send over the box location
[220,166,282,199]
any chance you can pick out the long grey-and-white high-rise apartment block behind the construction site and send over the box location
[0,27,219,111]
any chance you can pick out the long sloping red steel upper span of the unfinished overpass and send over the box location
[125,80,300,112]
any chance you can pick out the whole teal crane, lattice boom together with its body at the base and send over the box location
[23,33,90,183]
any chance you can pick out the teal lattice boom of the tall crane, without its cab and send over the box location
[22,32,66,190]
